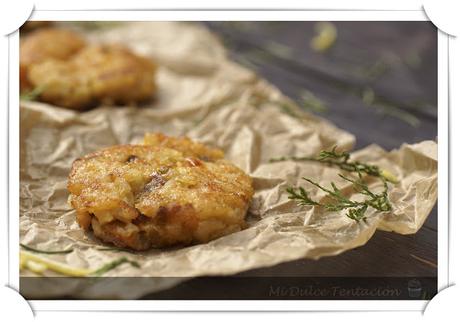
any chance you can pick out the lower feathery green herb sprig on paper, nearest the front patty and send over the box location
[286,173,391,222]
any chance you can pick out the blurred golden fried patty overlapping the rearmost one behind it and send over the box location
[29,45,155,109]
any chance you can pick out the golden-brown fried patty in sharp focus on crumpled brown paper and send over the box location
[68,134,253,250]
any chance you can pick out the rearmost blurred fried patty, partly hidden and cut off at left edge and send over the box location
[19,28,86,90]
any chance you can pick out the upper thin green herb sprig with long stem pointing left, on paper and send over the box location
[270,146,398,183]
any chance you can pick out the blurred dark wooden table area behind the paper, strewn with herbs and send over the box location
[206,21,437,149]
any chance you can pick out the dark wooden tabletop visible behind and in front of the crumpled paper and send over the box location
[147,22,437,299]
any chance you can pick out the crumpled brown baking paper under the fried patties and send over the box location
[20,22,437,298]
